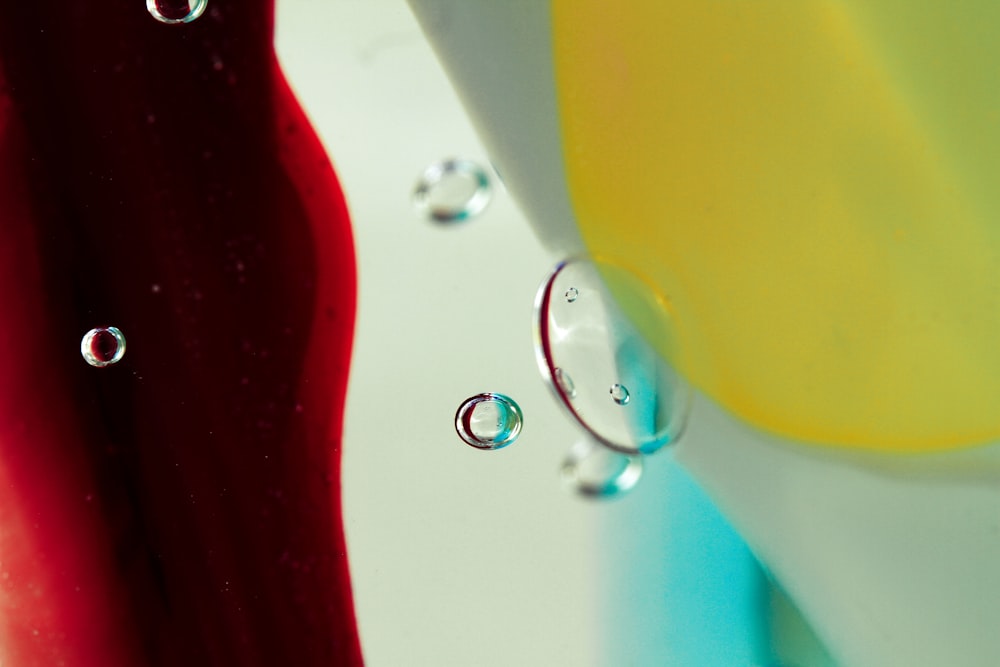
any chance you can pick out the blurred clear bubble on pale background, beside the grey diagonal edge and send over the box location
[413,159,492,222]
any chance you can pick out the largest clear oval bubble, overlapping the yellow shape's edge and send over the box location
[535,259,691,454]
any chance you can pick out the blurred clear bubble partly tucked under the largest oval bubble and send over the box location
[560,438,643,499]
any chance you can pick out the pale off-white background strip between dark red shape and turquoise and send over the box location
[277,0,624,667]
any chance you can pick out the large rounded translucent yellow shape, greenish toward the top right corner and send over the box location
[553,0,1000,451]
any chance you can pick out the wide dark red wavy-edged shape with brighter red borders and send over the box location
[0,0,361,667]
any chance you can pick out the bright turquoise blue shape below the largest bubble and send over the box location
[599,452,775,667]
